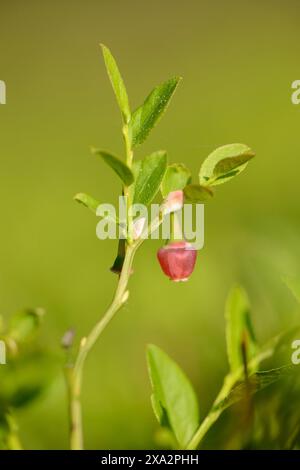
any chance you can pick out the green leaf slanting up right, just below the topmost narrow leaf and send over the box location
[129,77,180,147]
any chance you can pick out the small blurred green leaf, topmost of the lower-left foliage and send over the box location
[7,308,45,343]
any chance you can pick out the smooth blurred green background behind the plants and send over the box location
[0,0,300,449]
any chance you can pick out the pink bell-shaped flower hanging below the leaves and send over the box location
[157,241,197,282]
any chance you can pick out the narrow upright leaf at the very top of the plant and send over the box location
[101,44,130,123]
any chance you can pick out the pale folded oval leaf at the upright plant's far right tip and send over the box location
[199,144,255,186]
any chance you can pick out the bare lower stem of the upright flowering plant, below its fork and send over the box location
[66,244,138,450]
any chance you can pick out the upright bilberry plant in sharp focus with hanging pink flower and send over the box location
[69,45,254,449]
